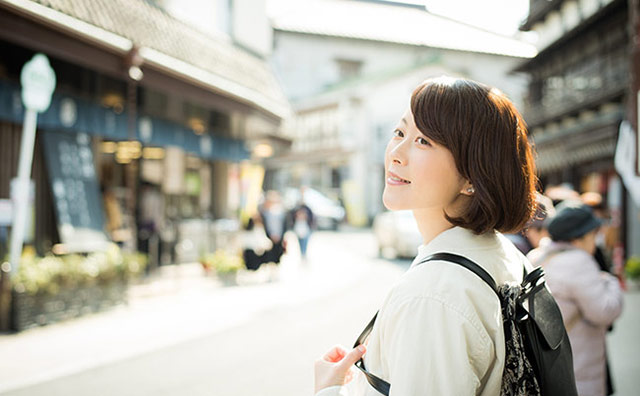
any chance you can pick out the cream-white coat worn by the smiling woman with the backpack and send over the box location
[316,227,530,396]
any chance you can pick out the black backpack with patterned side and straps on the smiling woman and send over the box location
[355,253,578,396]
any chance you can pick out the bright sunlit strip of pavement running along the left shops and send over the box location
[0,232,376,394]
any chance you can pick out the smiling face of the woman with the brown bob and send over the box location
[382,110,470,215]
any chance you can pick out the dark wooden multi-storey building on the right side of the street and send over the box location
[516,0,640,254]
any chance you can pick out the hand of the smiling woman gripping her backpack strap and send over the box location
[315,345,366,393]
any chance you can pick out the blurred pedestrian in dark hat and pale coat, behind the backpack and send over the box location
[530,201,622,396]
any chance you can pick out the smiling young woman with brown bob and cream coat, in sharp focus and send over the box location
[315,77,536,396]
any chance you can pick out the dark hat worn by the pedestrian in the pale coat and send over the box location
[547,201,602,241]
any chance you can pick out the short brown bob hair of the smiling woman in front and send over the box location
[411,76,537,234]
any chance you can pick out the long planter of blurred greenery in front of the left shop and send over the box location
[11,244,147,330]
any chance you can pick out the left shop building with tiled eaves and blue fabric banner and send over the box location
[0,0,289,263]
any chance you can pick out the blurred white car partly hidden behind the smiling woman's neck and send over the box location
[373,210,422,258]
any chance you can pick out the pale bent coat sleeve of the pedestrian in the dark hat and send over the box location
[570,255,623,326]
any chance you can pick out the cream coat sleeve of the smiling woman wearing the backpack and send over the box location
[381,296,495,396]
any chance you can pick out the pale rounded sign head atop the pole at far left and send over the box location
[20,54,56,113]
